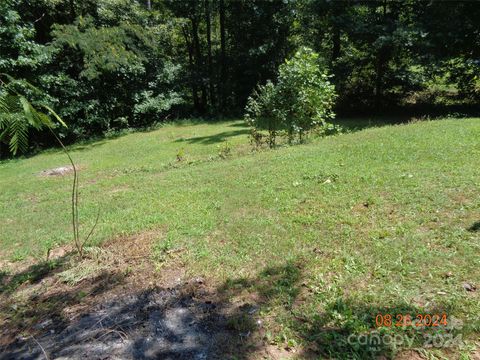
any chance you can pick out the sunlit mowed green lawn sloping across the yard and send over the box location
[0,119,480,358]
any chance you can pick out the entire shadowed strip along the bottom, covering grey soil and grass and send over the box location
[0,261,464,360]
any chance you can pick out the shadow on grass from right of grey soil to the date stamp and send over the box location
[221,262,460,359]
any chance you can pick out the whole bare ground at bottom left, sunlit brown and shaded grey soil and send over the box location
[0,232,261,360]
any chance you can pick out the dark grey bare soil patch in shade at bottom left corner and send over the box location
[0,284,242,359]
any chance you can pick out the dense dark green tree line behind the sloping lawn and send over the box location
[0,0,480,151]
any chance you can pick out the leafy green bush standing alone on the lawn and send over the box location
[245,48,336,147]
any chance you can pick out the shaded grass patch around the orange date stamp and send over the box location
[291,297,456,359]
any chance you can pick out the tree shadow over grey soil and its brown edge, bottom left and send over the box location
[0,266,256,360]
